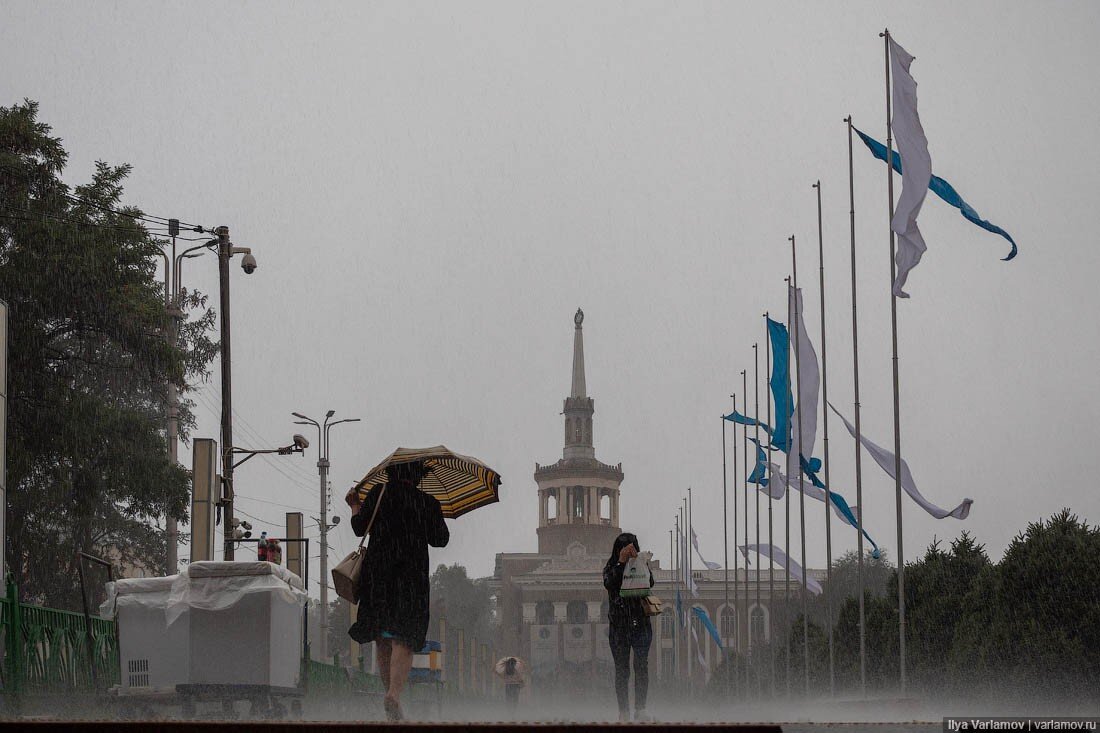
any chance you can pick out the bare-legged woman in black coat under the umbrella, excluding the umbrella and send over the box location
[348,461,450,720]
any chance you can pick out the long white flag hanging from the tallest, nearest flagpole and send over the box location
[890,36,932,298]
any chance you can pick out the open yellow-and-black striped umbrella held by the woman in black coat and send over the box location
[354,446,501,519]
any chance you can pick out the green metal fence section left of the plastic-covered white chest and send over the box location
[0,583,119,693]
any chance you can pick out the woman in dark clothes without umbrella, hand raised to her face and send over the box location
[604,532,653,722]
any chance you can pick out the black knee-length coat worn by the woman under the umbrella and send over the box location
[348,483,450,652]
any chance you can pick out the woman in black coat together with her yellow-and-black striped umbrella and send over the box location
[345,446,501,721]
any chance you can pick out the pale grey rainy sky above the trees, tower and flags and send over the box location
[0,0,1100,589]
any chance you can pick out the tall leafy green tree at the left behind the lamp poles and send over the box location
[0,101,217,608]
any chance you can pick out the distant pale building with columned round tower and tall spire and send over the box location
[492,309,820,691]
